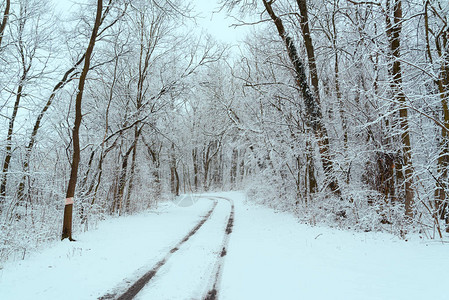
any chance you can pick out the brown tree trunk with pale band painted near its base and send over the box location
[61,0,103,241]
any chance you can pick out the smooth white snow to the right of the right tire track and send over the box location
[220,192,449,299]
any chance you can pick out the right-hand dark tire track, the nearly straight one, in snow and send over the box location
[203,197,234,300]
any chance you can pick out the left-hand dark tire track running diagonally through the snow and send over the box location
[98,199,218,300]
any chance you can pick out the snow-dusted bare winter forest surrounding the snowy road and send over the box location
[0,0,449,261]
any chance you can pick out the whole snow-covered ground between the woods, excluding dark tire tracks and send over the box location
[0,192,449,300]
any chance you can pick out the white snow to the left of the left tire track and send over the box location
[0,200,211,299]
